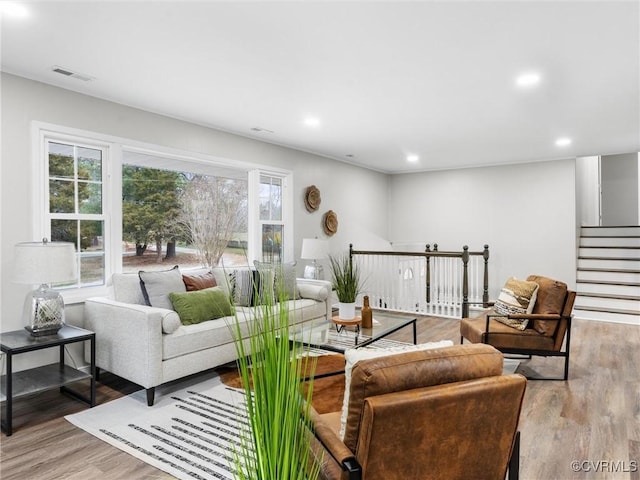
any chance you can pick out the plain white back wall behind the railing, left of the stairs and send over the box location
[389,160,576,299]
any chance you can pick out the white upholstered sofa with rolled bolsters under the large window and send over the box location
[84,269,331,406]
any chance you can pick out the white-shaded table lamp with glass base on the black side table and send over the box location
[14,238,76,337]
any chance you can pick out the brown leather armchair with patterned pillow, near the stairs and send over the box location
[460,275,576,380]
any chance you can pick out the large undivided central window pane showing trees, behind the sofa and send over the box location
[122,151,248,272]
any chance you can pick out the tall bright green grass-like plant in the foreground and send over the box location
[229,274,320,480]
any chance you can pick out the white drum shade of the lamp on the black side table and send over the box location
[13,240,76,285]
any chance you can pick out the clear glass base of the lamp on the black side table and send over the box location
[23,284,64,337]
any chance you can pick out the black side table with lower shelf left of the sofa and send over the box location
[0,325,96,436]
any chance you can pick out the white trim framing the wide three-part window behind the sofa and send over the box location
[31,121,294,304]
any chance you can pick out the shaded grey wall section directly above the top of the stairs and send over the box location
[600,153,640,226]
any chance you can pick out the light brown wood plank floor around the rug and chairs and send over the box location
[0,318,640,480]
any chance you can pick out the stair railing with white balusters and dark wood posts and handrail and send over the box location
[349,244,489,318]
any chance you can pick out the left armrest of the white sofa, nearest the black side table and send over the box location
[84,297,179,388]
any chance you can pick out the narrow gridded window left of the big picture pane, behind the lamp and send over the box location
[45,139,107,287]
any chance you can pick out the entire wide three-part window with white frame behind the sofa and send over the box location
[33,123,293,303]
